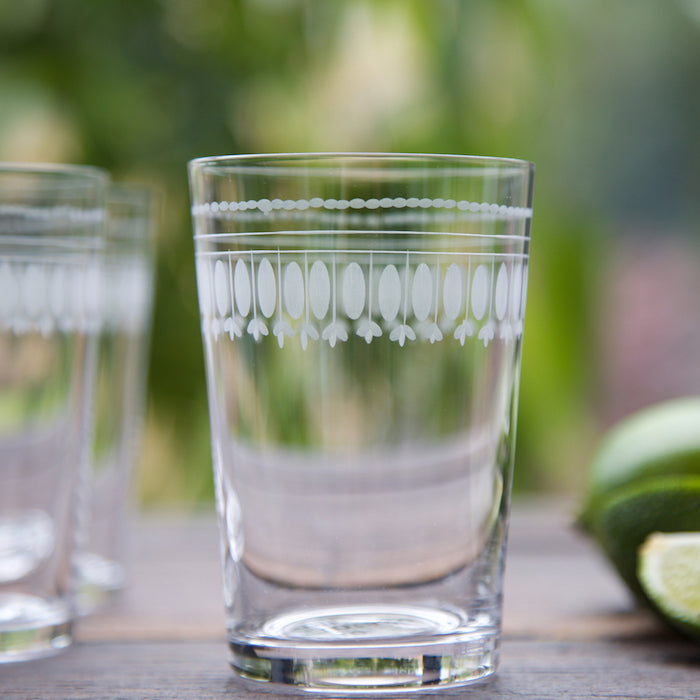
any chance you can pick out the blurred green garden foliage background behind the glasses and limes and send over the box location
[0,0,700,504]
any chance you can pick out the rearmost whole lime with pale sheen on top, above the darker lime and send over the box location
[580,396,700,527]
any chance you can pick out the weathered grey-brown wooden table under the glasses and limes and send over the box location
[0,501,700,700]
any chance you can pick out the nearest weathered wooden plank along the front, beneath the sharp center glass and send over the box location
[0,636,700,700]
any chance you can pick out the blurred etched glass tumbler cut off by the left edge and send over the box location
[0,165,107,662]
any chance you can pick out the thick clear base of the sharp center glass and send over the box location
[229,605,498,695]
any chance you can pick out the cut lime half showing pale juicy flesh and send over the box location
[638,532,700,639]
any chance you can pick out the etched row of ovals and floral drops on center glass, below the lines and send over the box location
[197,249,527,349]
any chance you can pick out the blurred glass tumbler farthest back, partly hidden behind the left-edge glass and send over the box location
[77,183,154,614]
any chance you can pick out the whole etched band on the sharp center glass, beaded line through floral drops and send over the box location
[192,197,532,350]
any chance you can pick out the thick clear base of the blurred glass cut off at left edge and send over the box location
[0,593,73,664]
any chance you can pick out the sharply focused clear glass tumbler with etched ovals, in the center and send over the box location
[189,154,534,694]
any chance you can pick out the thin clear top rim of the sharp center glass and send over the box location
[187,151,535,176]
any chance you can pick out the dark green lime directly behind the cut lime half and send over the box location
[589,475,700,600]
